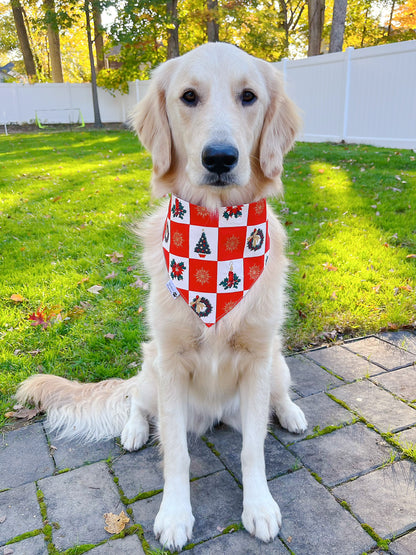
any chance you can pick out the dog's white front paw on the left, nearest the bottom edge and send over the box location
[153,502,195,551]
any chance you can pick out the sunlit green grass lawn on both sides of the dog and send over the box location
[0,131,416,423]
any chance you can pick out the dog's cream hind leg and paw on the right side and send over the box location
[270,350,308,434]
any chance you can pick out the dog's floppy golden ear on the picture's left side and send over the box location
[131,62,172,177]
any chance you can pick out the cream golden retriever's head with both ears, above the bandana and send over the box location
[133,43,298,208]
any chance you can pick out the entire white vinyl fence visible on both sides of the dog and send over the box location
[0,40,416,149]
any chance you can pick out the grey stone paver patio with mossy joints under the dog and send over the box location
[0,332,416,555]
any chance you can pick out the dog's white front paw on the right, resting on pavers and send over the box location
[242,494,282,542]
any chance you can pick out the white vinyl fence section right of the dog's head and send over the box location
[277,40,416,149]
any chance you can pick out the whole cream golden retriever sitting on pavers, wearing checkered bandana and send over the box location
[17,43,307,549]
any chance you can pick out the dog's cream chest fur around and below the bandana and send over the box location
[136,200,286,433]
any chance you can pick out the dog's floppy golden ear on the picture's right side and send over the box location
[260,62,300,179]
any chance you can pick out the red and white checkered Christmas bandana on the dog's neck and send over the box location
[162,195,270,326]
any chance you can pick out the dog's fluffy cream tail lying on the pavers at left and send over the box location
[16,374,135,442]
